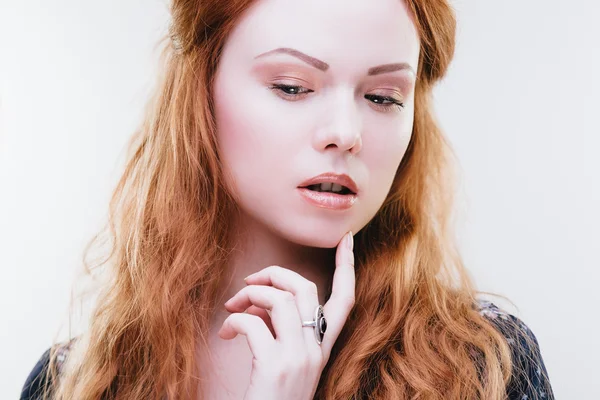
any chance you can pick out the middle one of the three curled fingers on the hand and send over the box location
[225,285,304,346]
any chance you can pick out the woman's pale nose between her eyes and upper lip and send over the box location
[315,90,362,155]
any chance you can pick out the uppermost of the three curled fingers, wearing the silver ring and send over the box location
[245,265,320,352]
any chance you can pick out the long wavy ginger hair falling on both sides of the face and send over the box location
[42,0,524,400]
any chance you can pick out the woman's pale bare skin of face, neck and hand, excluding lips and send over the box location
[198,0,419,400]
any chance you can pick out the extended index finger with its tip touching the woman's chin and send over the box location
[321,232,356,355]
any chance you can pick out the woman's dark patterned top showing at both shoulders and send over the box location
[20,301,554,400]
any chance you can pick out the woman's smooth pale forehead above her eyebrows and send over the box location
[221,0,419,76]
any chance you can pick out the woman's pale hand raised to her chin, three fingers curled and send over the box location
[219,232,355,400]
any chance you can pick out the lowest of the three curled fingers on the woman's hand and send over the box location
[218,313,276,360]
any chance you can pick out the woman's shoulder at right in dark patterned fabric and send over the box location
[477,300,554,400]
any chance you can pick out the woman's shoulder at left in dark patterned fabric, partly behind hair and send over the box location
[20,340,74,400]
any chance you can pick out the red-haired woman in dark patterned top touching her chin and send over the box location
[22,0,553,399]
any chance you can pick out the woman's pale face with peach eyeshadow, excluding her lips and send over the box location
[213,0,419,248]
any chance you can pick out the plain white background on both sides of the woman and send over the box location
[0,0,600,399]
